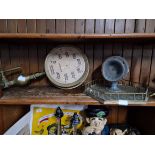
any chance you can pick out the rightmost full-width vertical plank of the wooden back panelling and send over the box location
[140,19,155,86]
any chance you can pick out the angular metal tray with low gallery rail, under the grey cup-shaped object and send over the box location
[85,80,148,103]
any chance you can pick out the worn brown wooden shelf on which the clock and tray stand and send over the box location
[0,87,155,106]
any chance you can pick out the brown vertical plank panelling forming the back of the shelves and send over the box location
[0,19,155,133]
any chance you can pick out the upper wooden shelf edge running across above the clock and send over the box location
[0,33,155,40]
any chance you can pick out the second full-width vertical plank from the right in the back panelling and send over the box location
[130,19,145,86]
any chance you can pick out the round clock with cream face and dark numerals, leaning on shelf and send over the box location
[45,46,89,88]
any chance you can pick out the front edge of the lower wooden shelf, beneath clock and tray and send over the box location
[0,96,155,107]
